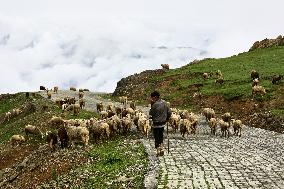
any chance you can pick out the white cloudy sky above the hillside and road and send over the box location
[0,0,284,93]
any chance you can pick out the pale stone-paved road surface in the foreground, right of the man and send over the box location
[150,118,284,189]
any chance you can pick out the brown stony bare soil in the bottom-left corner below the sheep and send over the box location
[0,145,87,189]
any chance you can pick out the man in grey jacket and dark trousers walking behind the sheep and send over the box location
[149,91,172,156]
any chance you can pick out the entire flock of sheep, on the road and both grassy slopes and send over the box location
[5,64,283,150]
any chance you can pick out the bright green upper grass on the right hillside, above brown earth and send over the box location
[147,47,284,104]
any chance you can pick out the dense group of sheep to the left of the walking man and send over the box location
[7,86,151,150]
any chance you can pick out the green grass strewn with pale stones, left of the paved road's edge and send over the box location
[45,134,148,189]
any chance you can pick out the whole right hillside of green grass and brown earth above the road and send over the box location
[114,46,284,131]
